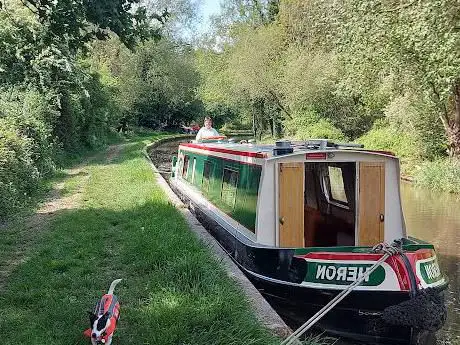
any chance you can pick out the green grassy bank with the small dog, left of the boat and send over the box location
[0,135,278,345]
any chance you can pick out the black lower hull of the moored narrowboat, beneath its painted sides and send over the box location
[171,183,442,345]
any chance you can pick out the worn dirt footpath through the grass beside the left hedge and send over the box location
[0,144,122,291]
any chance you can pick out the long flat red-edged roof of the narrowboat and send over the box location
[180,139,396,159]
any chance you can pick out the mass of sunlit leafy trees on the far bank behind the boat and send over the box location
[200,0,460,171]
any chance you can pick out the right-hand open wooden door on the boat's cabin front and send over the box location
[358,162,385,246]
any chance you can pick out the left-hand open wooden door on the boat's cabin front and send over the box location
[279,163,305,247]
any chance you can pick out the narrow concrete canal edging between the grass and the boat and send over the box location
[142,135,292,338]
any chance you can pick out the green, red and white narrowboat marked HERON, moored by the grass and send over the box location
[170,140,447,344]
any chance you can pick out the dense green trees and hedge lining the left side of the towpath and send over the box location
[0,0,188,219]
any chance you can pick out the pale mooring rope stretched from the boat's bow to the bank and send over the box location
[281,243,401,345]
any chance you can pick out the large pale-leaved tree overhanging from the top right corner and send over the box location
[281,0,460,156]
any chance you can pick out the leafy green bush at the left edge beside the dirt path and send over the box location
[0,88,57,220]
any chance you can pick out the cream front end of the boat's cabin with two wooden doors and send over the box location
[256,150,406,248]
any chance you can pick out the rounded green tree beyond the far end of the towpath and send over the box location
[116,38,202,128]
